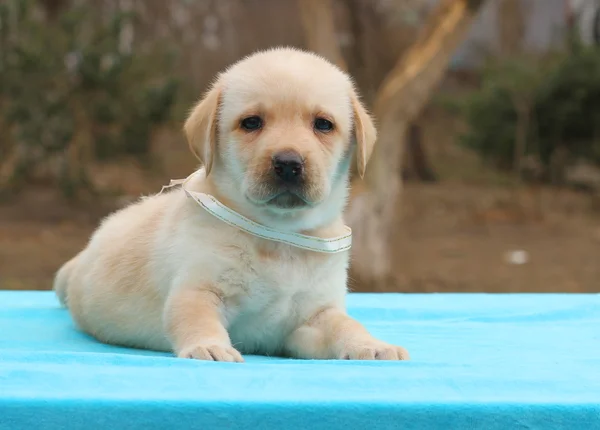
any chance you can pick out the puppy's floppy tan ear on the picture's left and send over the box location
[183,86,221,176]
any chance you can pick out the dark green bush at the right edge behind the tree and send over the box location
[454,45,600,178]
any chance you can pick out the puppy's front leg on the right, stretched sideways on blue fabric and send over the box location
[286,308,409,360]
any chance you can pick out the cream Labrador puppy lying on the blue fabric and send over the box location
[54,48,408,362]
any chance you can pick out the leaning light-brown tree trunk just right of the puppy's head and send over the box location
[347,0,483,290]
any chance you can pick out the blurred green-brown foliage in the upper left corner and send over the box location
[0,0,178,195]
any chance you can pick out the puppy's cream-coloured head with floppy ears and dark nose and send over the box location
[185,48,376,228]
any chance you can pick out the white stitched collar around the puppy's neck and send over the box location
[159,173,352,254]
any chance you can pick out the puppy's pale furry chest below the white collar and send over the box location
[219,242,346,354]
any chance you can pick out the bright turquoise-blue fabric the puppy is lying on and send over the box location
[0,292,600,430]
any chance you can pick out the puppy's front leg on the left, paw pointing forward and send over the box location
[164,288,244,362]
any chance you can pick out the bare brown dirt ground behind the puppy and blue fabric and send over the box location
[0,184,600,292]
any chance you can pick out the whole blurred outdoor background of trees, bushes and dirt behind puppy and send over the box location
[0,0,600,292]
